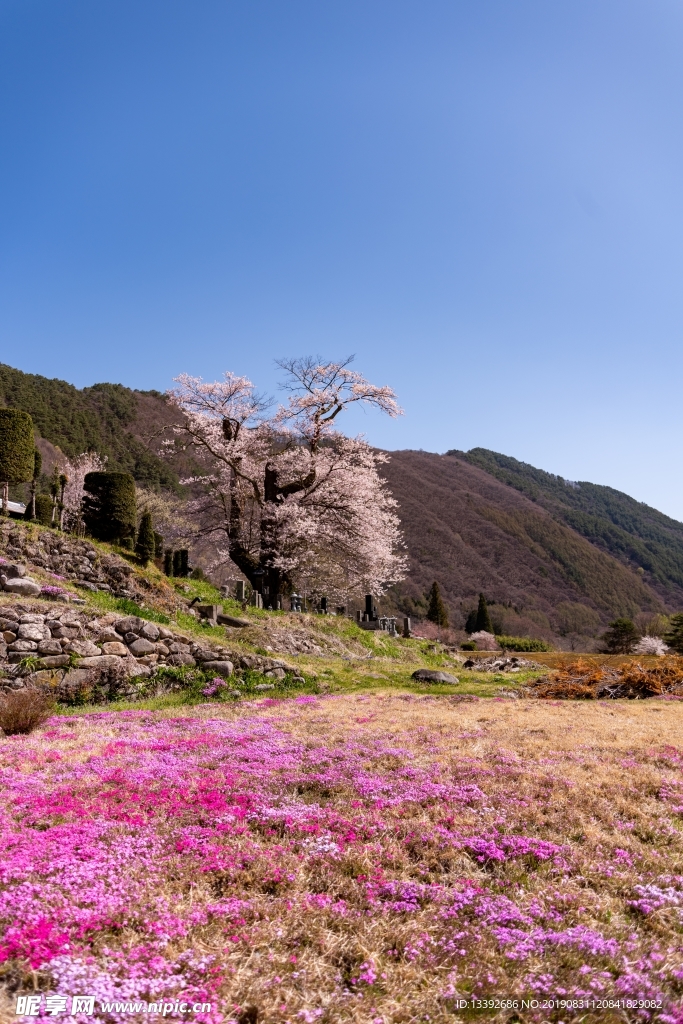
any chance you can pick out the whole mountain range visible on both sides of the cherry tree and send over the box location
[0,364,683,635]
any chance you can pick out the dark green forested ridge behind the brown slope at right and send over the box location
[456,449,683,591]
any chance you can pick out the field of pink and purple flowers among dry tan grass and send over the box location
[0,691,683,1024]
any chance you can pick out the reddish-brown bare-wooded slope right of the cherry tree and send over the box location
[384,452,683,635]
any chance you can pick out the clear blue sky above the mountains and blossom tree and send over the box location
[0,0,683,519]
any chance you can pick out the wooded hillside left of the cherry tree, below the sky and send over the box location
[0,364,178,489]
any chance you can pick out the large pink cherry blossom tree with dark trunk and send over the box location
[169,358,405,606]
